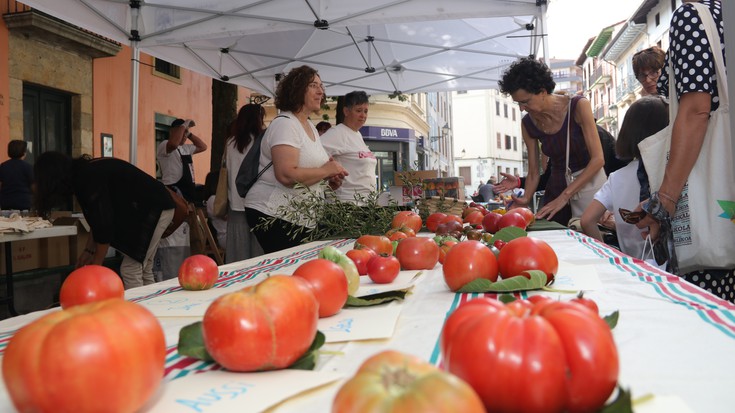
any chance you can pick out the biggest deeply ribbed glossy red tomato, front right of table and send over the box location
[443,300,619,413]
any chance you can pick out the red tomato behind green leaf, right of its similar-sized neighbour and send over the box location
[498,237,559,280]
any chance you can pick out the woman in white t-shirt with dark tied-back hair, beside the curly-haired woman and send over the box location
[321,91,378,204]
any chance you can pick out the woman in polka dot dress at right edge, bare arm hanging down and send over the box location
[639,0,735,302]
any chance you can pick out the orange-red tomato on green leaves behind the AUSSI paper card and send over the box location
[202,275,319,371]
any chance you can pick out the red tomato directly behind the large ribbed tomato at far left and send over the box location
[59,265,125,309]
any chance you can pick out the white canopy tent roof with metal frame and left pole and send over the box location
[24,0,547,163]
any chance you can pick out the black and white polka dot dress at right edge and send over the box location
[658,0,735,302]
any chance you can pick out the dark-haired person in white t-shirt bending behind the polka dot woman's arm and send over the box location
[582,96,669,258]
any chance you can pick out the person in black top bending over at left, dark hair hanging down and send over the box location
[34,152,174,289]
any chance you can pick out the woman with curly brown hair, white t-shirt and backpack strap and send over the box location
[245,66,347,253]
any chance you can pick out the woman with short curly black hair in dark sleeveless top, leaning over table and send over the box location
[498,58,605,226]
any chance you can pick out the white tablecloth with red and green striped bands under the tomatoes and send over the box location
[0,230,735,413]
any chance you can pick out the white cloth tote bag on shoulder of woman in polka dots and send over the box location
[638,3,735,274]
